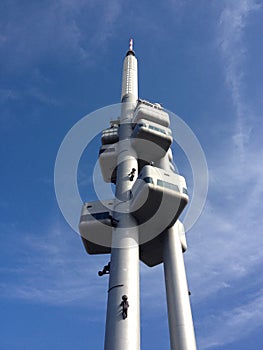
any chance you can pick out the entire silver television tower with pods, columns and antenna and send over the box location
[79,39,196,350]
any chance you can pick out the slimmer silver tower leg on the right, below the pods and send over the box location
[163,223,196,350]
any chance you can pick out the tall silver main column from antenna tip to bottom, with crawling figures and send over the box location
[105,43,140,350]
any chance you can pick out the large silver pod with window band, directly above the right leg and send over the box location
[131,165,189,228]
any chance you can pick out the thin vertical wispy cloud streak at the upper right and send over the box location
[218,0,261,162]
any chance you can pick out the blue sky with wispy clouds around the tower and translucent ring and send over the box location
[0,0,263,350]
